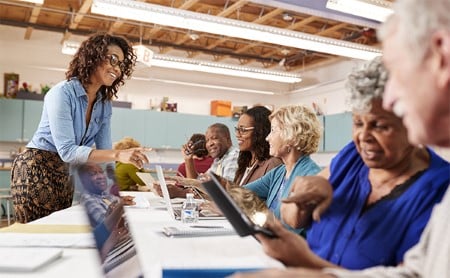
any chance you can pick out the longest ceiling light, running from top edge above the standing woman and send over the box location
[91,0,381,60]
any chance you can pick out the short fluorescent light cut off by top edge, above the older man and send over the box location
[326,0,394,22]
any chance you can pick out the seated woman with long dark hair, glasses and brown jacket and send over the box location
[233,106,282,186]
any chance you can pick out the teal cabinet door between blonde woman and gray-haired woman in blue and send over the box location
[325,113,352,152]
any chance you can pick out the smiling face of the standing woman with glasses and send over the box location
[91,45,124,87]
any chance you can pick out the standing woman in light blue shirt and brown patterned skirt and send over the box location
[11,34,148,223]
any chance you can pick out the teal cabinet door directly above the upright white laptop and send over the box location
[140,111,171,148]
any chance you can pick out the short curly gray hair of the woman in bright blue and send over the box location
[346,57,388,112]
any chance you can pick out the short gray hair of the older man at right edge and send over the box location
[378,0,450,63]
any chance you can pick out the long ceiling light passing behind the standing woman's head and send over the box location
[62,41,302,83]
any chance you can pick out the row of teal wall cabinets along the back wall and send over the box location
[0,99,352,152]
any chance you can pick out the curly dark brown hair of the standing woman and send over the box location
[66,33,136,101]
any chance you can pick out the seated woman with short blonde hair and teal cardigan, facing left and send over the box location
[244,106,321,232]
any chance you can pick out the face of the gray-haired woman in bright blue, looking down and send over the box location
[352,100,413,169]
